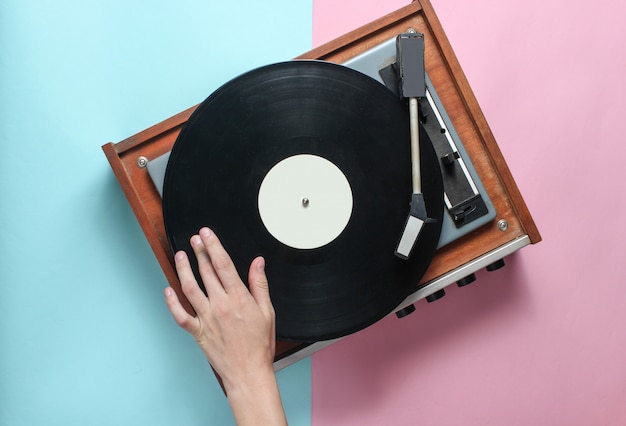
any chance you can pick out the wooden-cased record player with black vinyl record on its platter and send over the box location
[103,0,541,369]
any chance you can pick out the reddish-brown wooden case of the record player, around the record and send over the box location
[102,0,541,369]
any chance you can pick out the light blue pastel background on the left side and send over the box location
[0,0,312,426]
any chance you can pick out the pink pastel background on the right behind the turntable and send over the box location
[312,0,626,426]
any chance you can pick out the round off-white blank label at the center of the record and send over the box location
[258,154,352,249]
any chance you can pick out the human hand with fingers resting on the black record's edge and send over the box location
[165,228,284,424]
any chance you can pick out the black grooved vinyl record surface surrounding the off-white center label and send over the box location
[163,61,443,342]
